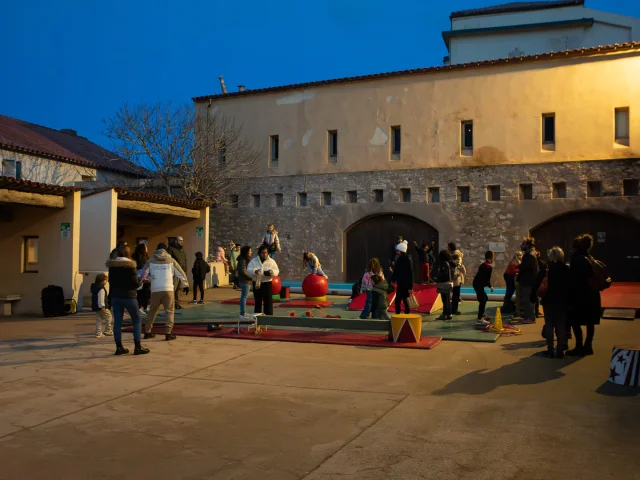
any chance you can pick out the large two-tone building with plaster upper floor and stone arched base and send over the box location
[194,10,640,284]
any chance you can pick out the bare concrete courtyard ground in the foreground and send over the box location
[0,289,640,480]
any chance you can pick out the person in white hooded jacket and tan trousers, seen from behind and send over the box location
[142,243,189,341]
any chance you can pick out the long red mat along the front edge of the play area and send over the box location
[144,324,442,350]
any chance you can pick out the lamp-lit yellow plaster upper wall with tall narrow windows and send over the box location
[197,52,640,175]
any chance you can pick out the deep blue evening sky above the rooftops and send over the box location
[0,0,640,148]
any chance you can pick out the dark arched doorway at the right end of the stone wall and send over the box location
[531,210,640,282]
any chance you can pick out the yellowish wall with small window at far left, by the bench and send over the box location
[0,192,80,314]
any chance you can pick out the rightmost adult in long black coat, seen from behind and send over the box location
[567,234,601,357]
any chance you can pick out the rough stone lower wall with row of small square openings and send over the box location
[210,159,640,285]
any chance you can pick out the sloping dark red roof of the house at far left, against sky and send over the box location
[0,115,147,176]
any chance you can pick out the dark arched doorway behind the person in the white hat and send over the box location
[345,213,438,282]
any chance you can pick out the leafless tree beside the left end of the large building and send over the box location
[104,102,261,204]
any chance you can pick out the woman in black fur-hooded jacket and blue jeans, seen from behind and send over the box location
[107,245,149,355]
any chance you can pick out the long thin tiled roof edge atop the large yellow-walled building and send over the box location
[192,42,640,102]
